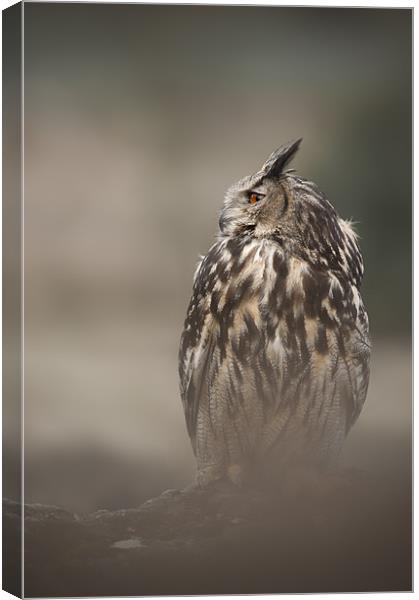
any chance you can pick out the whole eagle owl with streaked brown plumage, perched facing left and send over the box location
[179,140,370,485]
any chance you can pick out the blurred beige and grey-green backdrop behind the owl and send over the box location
[11,3,412,511]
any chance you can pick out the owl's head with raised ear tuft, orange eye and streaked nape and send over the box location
[219,139,362,280]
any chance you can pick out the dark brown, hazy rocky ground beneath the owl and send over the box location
[5,471,411,597]
